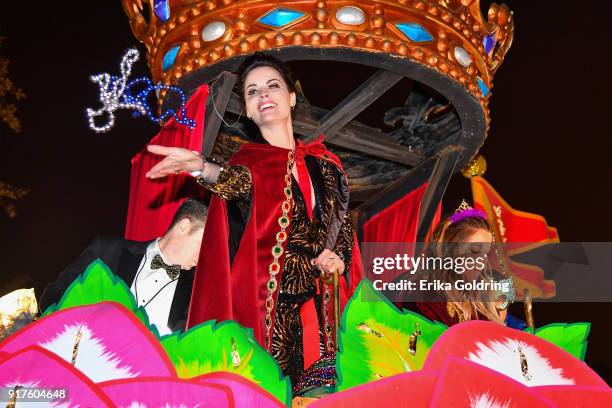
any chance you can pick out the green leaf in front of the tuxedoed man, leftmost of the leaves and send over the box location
[43,259,152,335]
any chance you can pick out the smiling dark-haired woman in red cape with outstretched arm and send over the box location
[147,54,363,389]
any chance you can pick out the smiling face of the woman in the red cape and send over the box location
[244,66,296,128]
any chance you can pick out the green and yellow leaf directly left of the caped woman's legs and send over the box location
[161,320,291,405]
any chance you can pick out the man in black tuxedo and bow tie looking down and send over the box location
[40,198,208,335]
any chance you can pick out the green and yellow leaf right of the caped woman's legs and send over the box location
[336,279,447,391]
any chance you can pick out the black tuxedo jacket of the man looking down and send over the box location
[39,237,195,331]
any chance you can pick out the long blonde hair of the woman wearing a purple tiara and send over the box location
[425,217,503,324]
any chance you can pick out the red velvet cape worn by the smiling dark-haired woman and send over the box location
[187,138,363,348]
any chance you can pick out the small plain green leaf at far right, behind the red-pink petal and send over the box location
[525,322,591,361]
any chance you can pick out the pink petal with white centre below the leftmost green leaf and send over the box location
[0,302,176,382]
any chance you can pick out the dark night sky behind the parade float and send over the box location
[0,0,612,383]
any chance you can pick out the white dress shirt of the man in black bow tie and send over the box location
[130,238,178,335]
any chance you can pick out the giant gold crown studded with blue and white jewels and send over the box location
[123,0,514,121]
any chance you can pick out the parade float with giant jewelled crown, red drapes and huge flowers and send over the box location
[0,0,612,408]
